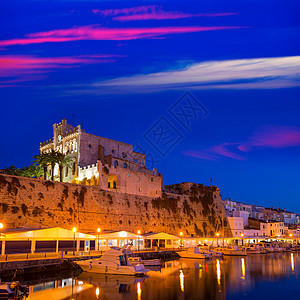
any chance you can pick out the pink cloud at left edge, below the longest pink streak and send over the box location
[0,54,119,84]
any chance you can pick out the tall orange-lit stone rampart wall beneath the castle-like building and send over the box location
[0,175,230,236]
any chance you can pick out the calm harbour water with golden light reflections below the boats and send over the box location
[29,253,300,300]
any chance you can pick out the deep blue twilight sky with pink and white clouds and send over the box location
[0,0,300,212]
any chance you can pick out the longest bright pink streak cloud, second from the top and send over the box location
[0,25,242,47]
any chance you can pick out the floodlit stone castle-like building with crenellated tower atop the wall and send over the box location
[40,119,164,197]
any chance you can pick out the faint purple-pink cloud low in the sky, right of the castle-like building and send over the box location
[184,126,300,161]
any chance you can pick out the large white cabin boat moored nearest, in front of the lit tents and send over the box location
[76,247,149,276]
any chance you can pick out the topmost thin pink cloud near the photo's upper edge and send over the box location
[92,5,237,22]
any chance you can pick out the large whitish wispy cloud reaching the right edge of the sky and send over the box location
[91,56,300,93]
